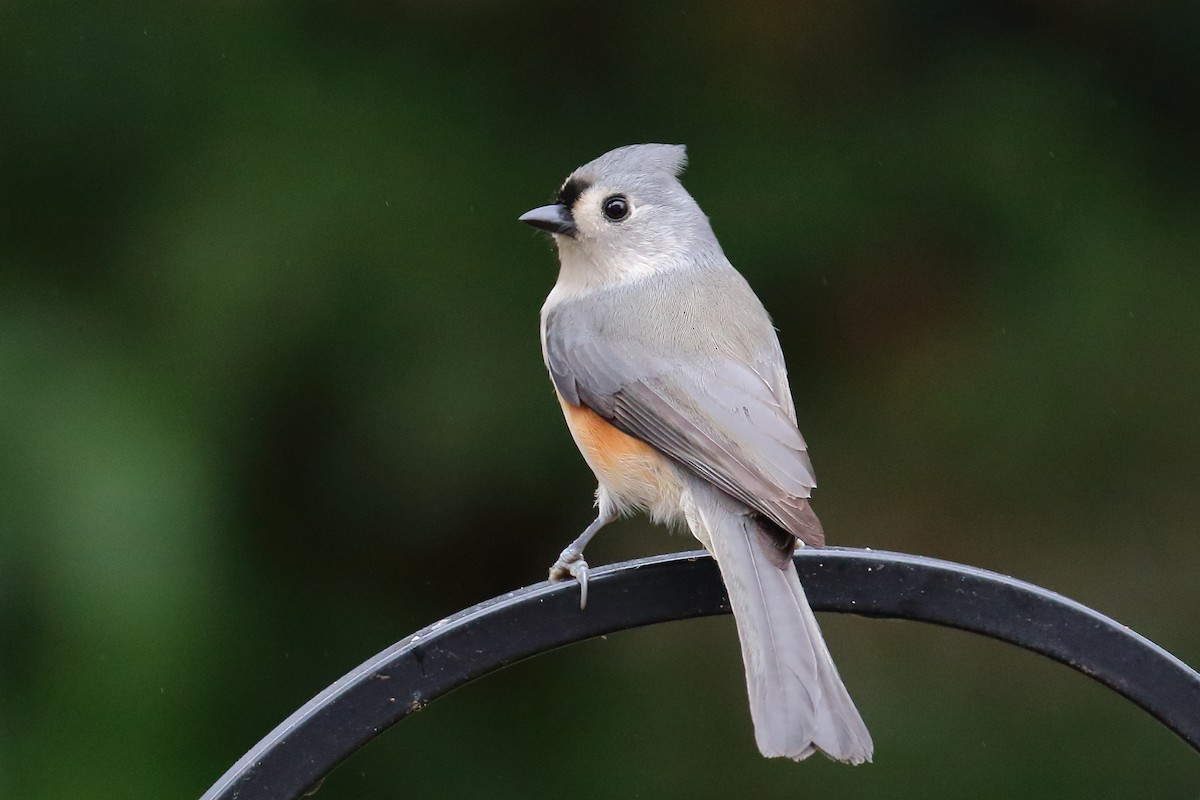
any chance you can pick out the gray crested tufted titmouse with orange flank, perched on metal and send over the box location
[520,144,871,764]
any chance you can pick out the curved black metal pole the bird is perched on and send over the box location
[202,547,1200,800]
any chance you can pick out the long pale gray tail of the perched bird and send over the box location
[688,482,874,764]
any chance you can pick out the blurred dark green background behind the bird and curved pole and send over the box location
[0,0,1200,800]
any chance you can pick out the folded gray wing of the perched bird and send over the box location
[546,321,824,545]
